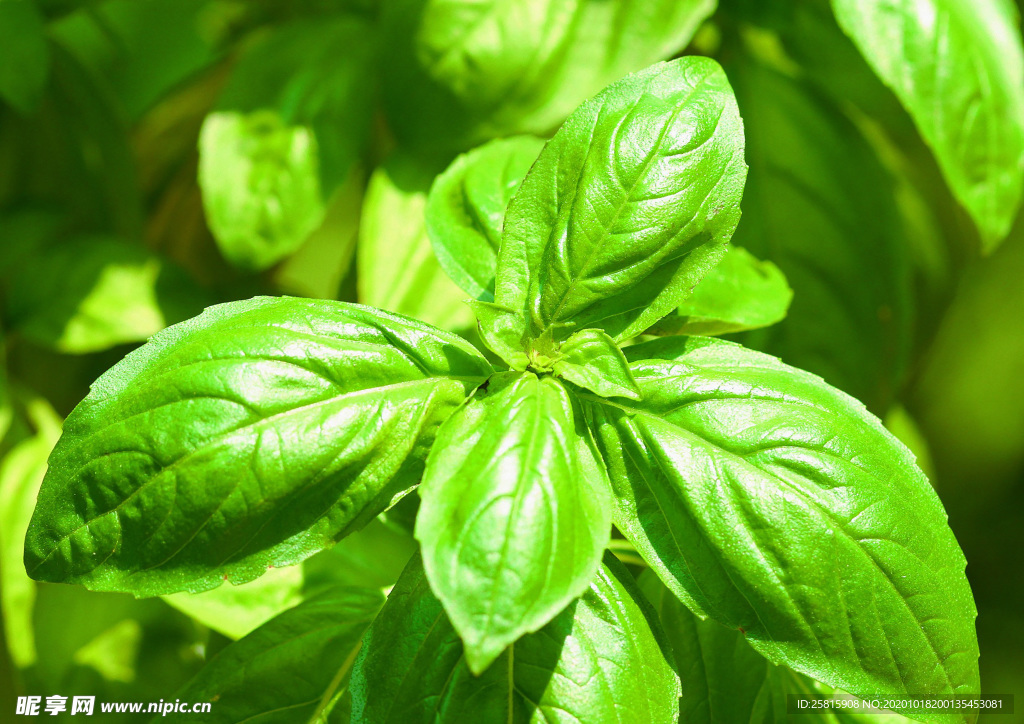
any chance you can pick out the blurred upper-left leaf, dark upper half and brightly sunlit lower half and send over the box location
[199,17,373,270]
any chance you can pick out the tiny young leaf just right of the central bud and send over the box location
[552,330,640,399]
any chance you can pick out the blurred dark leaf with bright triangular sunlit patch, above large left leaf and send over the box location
[7,237,208,353]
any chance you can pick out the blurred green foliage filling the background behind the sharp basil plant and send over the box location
[0,0,1024,722]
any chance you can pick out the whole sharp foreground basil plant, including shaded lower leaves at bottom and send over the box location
[26,56,979,724]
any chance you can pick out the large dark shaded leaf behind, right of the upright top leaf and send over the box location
[728,53,912,412]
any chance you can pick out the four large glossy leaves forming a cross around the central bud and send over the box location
[26,57,978,719]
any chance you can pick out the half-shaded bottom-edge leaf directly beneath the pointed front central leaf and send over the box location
[351,556,679,724]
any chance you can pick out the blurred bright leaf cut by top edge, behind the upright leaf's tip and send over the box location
[383,0,715,152]
